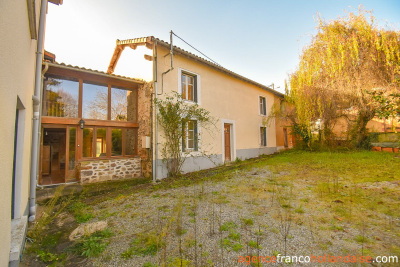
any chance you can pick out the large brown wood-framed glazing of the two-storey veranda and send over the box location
[42,70,139,163]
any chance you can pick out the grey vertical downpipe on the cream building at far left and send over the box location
[29,0,47,222]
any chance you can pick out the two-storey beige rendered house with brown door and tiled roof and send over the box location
[108,37,291,178]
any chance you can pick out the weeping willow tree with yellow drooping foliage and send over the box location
[286,8,400,147]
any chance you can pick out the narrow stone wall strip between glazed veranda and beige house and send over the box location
[138,82,153,177]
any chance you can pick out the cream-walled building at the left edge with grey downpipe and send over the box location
[0,0,62,266]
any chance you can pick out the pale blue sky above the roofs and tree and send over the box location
[45,0,400,94]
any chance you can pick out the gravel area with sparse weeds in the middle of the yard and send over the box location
[86,169,384,266]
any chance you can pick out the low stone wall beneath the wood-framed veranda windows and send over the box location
[80,157,142,184]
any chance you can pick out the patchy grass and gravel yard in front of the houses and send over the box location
[24,151,400,266]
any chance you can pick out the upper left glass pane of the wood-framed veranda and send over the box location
[43,77,79,118]
